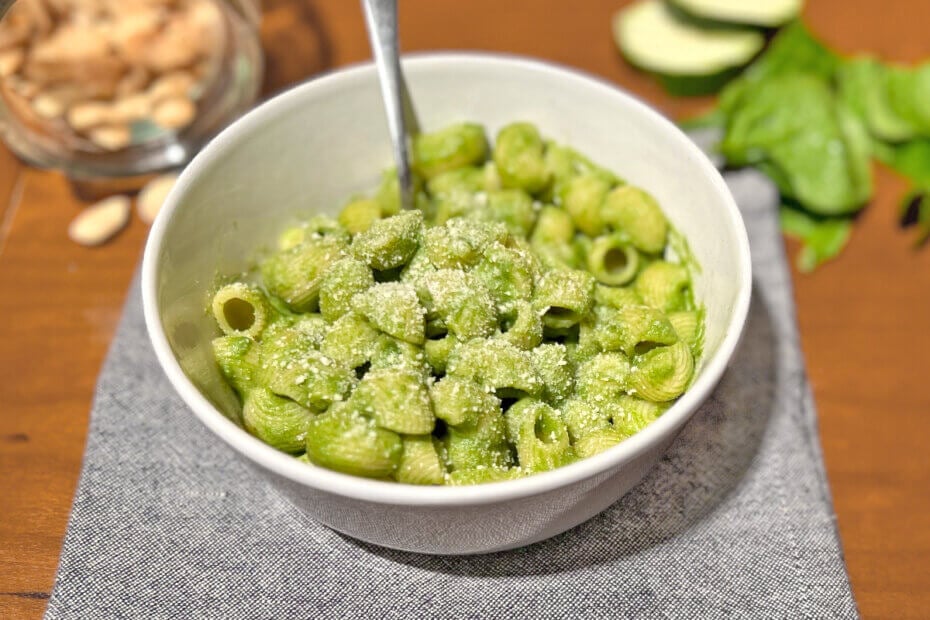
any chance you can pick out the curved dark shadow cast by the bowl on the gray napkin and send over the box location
[358,295,784,577]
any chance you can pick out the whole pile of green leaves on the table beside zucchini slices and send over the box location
[616,5,930,271]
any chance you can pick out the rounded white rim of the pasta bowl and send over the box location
[141,52,752,507]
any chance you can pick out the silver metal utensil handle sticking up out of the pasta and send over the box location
[362,0,417,209]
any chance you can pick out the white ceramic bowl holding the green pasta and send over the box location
[142,54,751,554]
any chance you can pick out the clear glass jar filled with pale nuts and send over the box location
[0,0,262,179]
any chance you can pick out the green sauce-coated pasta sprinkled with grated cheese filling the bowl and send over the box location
[208,118,704,485]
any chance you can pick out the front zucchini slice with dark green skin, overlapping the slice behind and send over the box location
[613,0,765,94]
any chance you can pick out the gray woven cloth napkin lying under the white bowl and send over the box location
[46,173,857,619]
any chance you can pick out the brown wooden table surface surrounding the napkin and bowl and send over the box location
[0,0,930,618]
